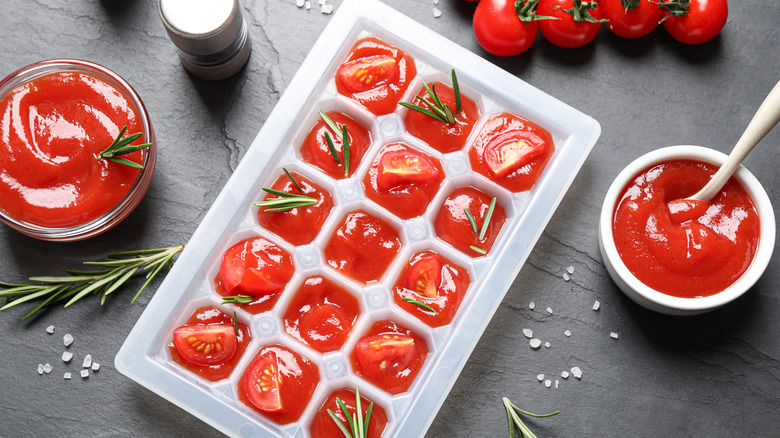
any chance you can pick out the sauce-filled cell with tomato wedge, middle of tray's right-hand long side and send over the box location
[393,250,471,327]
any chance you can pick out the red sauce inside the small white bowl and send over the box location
[612,160,761,298]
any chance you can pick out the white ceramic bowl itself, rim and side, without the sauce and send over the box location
[599,145,775,315]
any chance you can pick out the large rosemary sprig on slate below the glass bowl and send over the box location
[0,245,184,319]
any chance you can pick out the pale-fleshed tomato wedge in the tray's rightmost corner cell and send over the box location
[483,131,547,178]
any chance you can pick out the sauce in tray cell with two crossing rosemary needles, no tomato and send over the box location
[433,187,506,257]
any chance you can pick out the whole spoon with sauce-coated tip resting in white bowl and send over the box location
[669,82,780,223]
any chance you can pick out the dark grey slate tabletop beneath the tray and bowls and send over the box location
[0,0,780,437]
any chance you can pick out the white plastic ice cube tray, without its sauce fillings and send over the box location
[115,0,601,437]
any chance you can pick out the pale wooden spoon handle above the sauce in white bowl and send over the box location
[690,78,780,202]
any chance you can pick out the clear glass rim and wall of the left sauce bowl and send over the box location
[0,58,157,242]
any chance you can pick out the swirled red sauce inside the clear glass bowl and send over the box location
[0,72,145,228]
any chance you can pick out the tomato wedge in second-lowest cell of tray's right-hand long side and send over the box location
[355,334,417,377]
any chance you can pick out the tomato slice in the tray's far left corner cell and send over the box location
[173,324,238,366]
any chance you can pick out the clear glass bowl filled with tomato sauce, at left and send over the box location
[0,59,156,242]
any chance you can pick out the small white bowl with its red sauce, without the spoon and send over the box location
[599,145,775,315]
